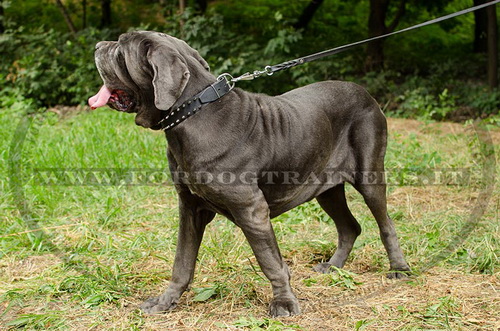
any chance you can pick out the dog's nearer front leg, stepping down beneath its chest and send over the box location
[232,190,300,317]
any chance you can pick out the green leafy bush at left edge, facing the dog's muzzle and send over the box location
[0,28,115,106]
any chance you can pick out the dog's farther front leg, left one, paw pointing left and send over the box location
[141,194,215,314]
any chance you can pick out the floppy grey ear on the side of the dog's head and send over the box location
[147,47,191,110]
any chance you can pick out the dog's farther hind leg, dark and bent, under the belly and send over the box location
[313,184,361,273]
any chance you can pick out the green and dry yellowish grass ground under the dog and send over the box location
[0,104,500,330]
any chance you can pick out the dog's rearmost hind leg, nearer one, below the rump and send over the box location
[354,184,410,278]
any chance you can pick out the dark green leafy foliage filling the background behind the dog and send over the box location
[0,0,500,120]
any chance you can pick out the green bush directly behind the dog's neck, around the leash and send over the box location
[159,10,308,94]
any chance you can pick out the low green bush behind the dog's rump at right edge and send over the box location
[353,68,500,121]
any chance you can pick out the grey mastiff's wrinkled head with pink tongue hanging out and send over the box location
[89,31,210,129]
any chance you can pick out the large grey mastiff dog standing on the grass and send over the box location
[89,31,410,316]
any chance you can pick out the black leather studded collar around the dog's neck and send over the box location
[158,77,234,131]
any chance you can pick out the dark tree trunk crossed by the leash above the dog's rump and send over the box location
[365,0,389,71]
